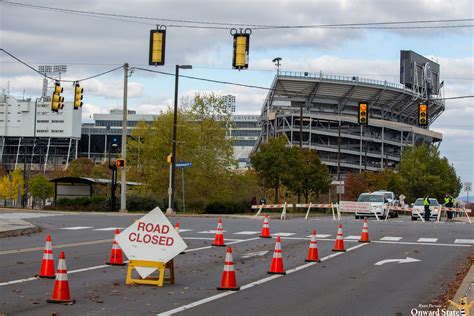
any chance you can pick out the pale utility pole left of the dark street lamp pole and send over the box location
[120,63,128,213]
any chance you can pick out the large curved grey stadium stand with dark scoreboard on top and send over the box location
[254,51,445,177]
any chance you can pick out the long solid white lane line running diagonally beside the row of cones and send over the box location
[158,244,367,316]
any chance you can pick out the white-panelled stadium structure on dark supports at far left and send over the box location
[0,94,82,170]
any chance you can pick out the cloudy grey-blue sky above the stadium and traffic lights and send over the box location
[0,0,474,190]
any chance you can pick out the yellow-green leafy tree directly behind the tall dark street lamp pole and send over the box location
[127,94,236,208]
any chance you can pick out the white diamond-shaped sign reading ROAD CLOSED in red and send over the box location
[115,207,187,278]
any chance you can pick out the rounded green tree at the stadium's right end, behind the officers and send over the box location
[397,145,462,202]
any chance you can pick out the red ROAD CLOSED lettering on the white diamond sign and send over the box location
[128,222,174,246]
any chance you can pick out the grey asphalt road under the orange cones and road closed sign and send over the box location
[0,213,474,315]
